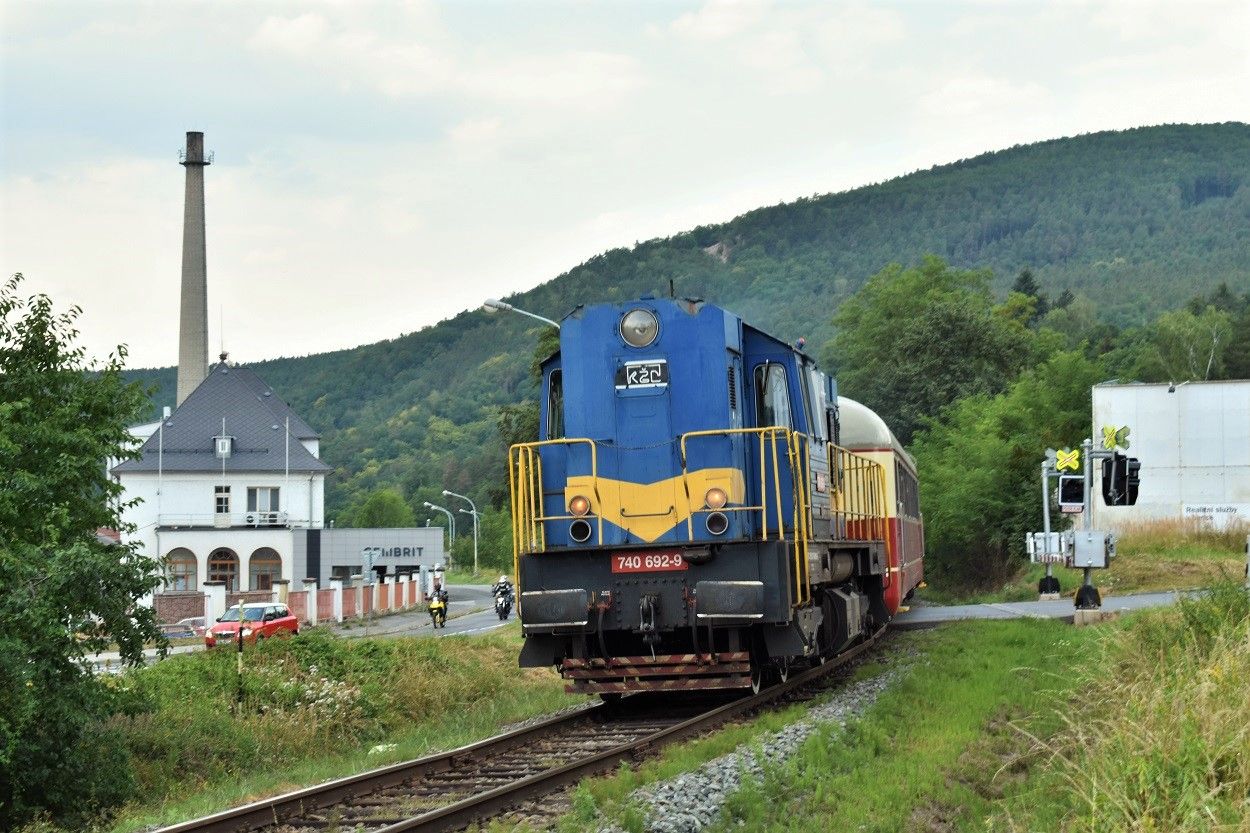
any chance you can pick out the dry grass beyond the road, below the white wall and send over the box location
[918,520,1250,604]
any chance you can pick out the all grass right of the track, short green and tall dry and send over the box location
[540,584,1250,833]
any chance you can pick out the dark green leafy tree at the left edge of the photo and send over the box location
[0,275,160,829]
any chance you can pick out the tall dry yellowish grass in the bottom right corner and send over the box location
[1004,583,1250,833]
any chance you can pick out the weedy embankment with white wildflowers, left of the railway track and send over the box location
[93,624,583,833]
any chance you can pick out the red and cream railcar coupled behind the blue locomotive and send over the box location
[838,396,925,615]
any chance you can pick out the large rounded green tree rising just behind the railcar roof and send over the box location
[825,256,1034,443]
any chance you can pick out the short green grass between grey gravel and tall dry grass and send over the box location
[721,620,1098,833]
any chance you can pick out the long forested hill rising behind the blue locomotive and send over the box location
[133,124,1250,523]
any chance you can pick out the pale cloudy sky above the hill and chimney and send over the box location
[0,0,1250,366]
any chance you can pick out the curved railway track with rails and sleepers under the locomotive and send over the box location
[156,628,885,833]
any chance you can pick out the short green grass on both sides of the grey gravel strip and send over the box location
[537,622,1096,833]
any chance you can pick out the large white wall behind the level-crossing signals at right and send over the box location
[1093,381,1250,528]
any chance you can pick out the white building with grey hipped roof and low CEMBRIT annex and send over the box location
[111,361,444,593]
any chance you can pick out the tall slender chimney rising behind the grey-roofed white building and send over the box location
[178,131,213,405]
